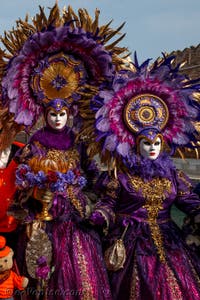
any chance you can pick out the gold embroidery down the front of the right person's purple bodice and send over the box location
[129,176,171,262]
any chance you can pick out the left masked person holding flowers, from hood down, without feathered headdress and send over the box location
[16,99,111,299]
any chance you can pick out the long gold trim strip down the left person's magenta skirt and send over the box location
[75,236,96,300]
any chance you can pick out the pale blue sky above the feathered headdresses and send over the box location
[0,0,200,62]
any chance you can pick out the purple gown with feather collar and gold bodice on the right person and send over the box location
[99,155,200,300]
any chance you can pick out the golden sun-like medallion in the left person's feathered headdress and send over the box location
[31,53,85,102]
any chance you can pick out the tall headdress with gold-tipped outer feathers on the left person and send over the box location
[0,4,128,128]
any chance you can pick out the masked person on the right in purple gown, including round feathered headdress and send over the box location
[82,56,200,300]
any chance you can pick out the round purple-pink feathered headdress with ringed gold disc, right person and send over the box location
[79,55,200,166]
